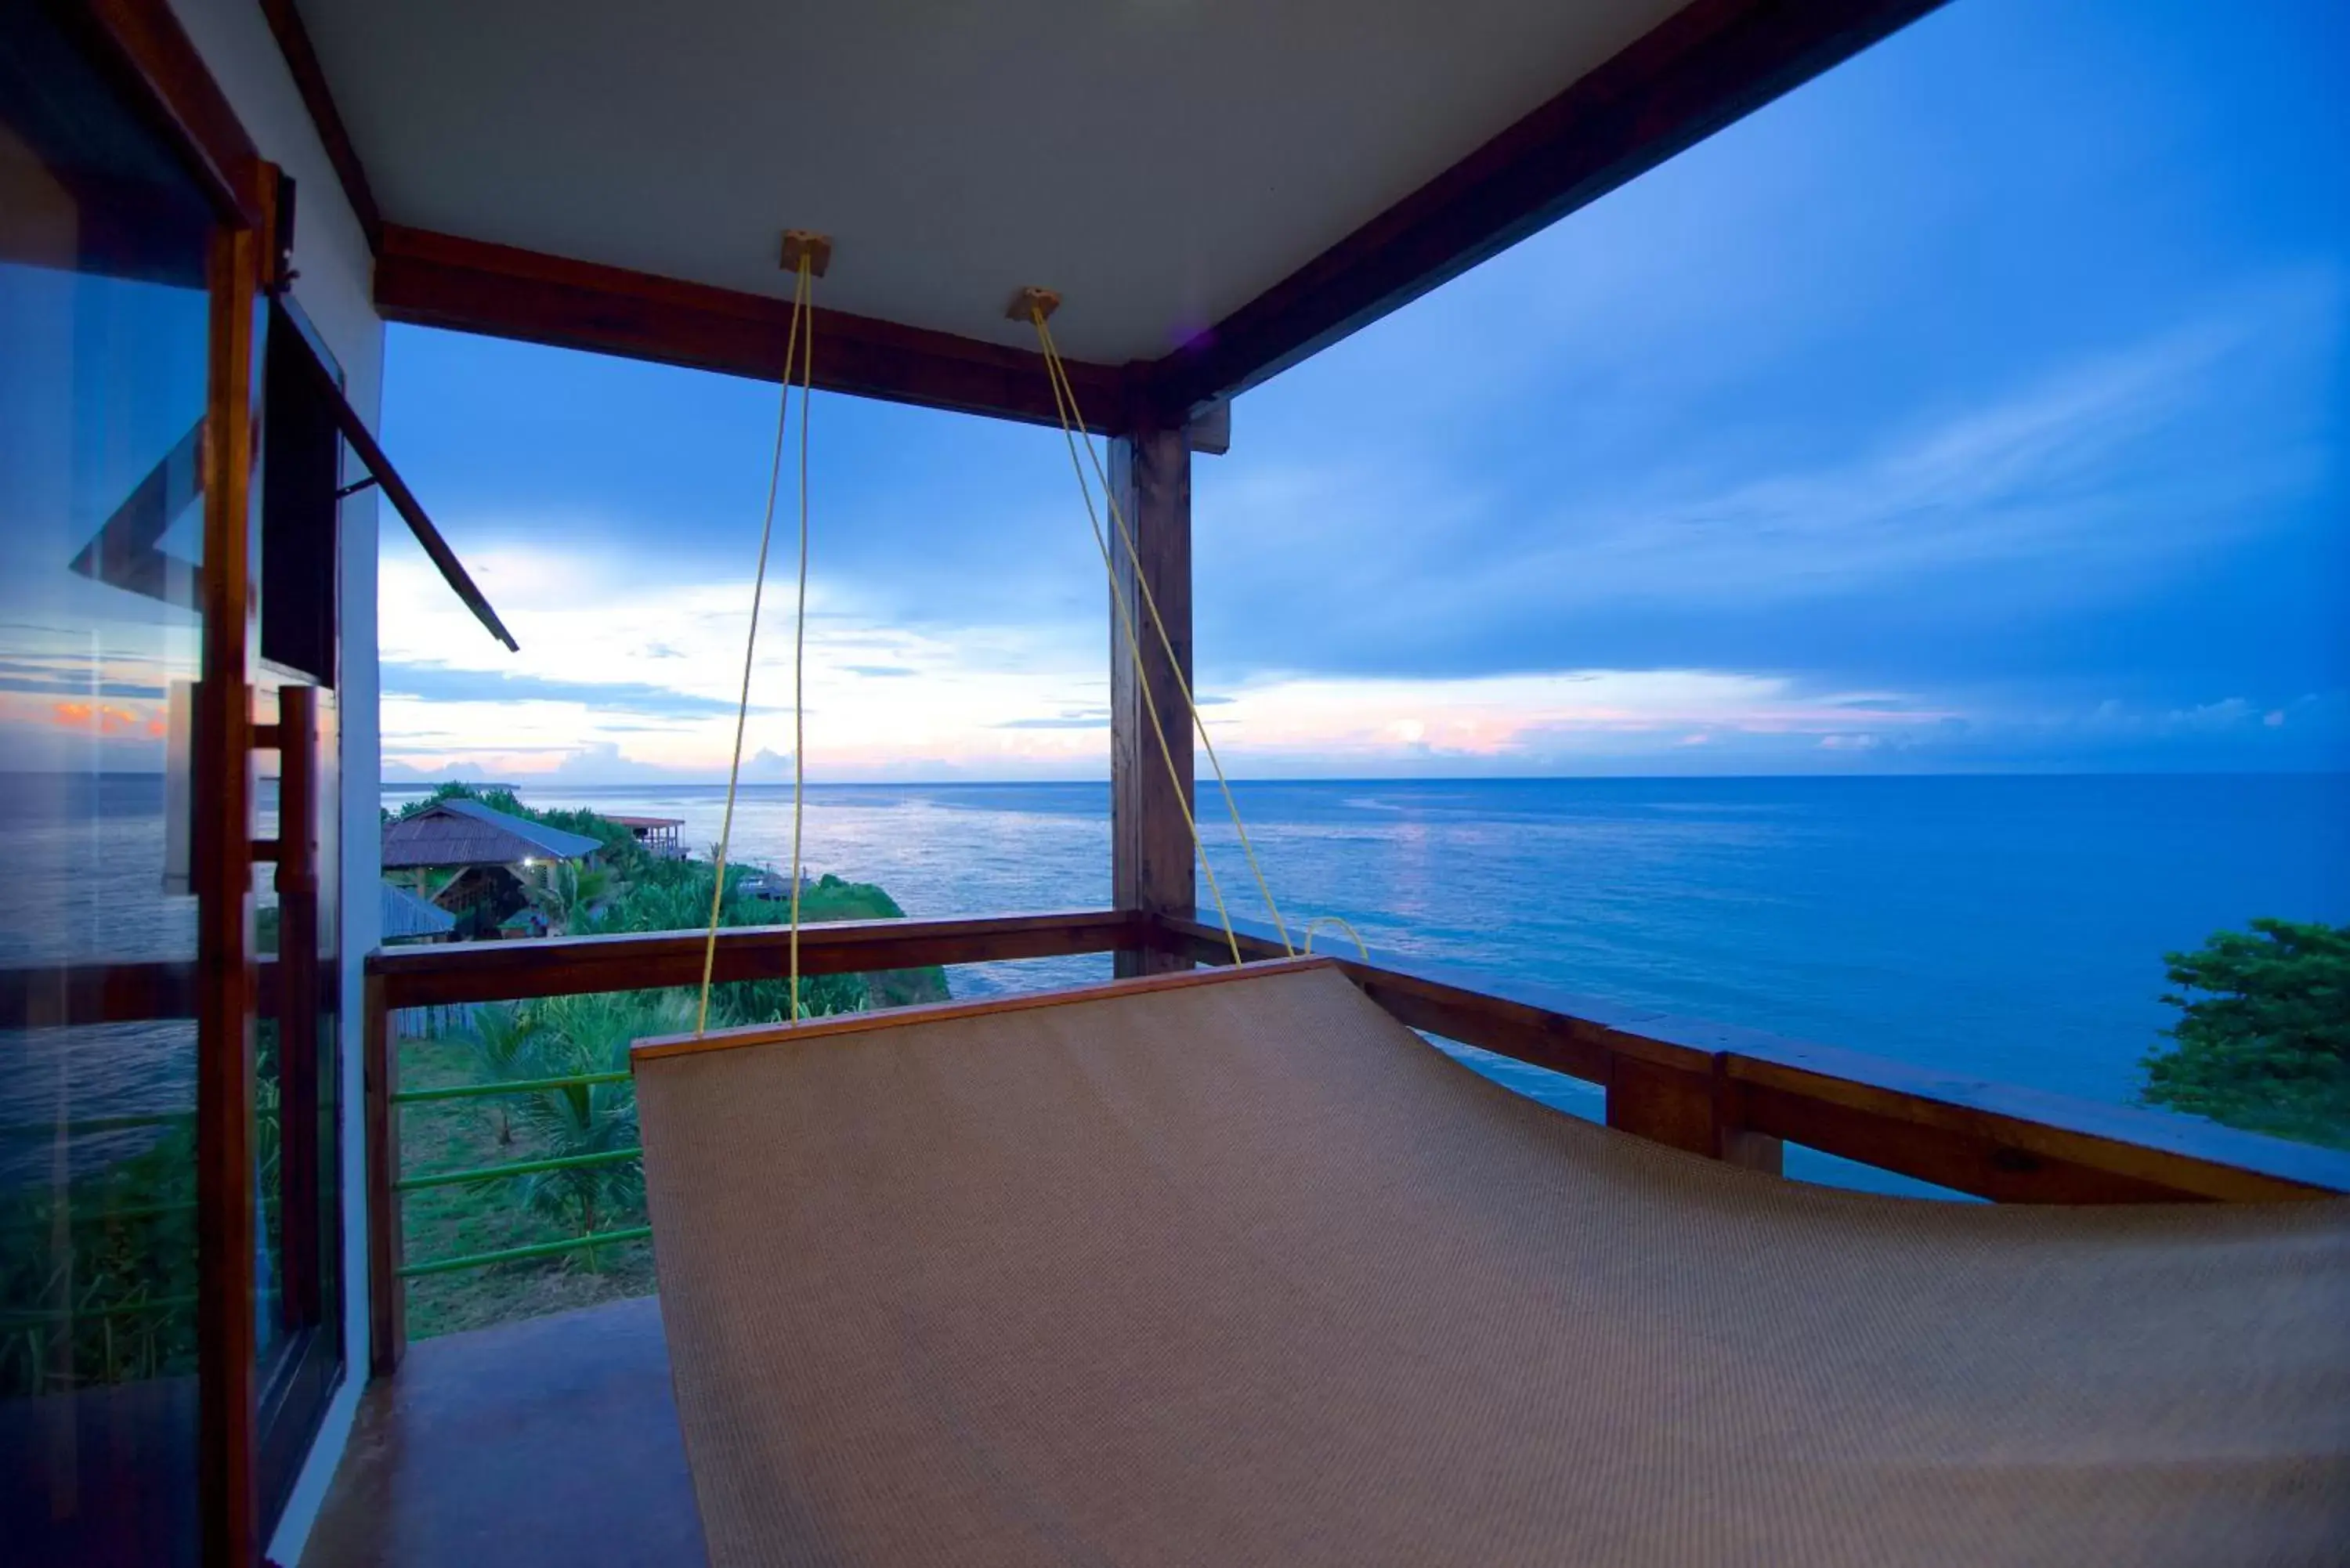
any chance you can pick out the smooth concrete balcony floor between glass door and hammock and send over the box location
[301,1298,707,1568]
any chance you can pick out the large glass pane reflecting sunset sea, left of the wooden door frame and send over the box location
[0,7,212,1563]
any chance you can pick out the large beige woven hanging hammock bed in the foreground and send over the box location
[637,969,2350,1568]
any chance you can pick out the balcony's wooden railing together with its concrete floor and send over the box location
[280,912,2350,1568]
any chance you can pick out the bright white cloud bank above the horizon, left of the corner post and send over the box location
[378,538,1109,780]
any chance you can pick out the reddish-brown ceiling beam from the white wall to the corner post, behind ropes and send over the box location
[376,223,1130,432]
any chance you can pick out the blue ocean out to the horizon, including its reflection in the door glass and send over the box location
[0,775,2350,1189]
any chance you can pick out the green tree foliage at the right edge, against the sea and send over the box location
[2143,919,2350,1147]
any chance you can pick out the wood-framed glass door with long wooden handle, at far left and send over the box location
[0,5,345,1568]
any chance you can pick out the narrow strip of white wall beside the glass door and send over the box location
[172,0,383,1563]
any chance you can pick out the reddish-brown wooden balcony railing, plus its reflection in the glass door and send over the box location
[18,910,2350,1373]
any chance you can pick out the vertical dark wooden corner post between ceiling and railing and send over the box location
[1102,428,1198,976]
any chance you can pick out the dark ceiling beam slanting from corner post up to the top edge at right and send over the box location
[1147,0,1943,416]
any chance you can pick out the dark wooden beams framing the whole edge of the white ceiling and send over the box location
[348,0,1943,432]
